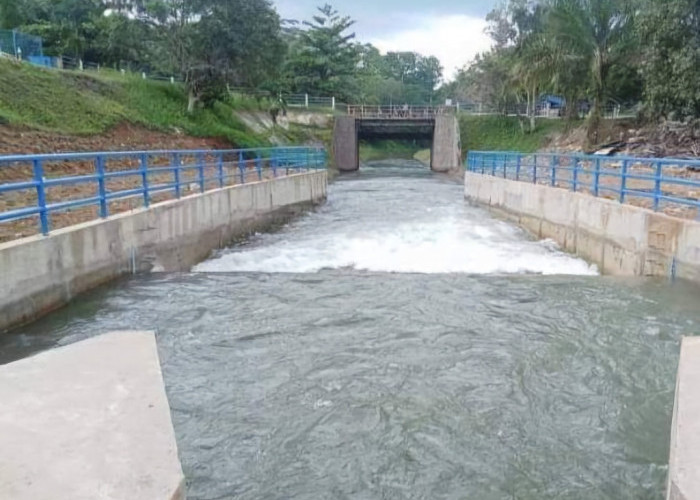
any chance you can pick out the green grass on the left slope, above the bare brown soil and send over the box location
[0,59,269,147]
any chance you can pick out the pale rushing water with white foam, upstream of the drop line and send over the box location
[194,170,598,275]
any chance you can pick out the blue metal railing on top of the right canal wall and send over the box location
[466,151,700,218]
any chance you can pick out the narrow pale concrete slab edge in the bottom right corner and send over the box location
[666,337,700,500]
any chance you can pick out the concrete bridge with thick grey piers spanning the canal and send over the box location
[333,105,462,172]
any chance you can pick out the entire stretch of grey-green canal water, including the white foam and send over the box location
[0,165,700,500]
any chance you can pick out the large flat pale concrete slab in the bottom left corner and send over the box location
[0,332,185,500]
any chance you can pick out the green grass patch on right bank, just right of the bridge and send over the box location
[459,115,567,153]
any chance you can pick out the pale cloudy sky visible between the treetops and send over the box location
[273,0,497,79]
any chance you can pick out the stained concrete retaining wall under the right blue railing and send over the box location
[465,172,700,282]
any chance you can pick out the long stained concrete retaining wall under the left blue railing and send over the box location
[0,171,327,331]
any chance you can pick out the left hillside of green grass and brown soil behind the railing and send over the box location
[0,59,328,153]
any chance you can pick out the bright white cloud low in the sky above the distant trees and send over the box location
[370,15,491,80]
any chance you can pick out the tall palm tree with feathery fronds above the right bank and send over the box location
[548,0,634,143]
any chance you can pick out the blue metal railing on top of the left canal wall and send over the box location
[0,147,326,235]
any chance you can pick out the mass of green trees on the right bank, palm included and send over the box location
[441,0,700,145]
